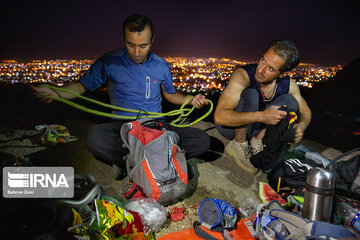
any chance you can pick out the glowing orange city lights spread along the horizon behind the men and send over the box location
[0,57,342,93]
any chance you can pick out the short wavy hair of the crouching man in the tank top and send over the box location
[265,40,300,73]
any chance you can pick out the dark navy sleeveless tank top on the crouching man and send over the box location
[242,64,290,108]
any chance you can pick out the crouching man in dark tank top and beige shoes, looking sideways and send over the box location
[214,40,311,173]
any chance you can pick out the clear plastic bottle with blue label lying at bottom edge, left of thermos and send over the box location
[255,213,289,239]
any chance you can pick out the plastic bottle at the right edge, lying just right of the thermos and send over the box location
[336,202,360,231]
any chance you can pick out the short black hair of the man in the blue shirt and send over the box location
[123,14,154,39]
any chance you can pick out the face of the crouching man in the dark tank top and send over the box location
[255,48,285,84]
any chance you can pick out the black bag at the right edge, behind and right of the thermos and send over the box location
[326,148,360,199]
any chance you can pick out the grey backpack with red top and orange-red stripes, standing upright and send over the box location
[121,118,188,204]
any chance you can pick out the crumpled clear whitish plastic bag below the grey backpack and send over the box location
[125,198,166,231]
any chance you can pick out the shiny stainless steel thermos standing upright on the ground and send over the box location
[302,167,335,222]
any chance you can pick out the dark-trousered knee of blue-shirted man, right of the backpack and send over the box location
[169,125,210,159]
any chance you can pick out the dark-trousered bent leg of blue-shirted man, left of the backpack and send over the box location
[86,121,129,179]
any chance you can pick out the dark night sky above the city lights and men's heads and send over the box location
[0,0,360,65]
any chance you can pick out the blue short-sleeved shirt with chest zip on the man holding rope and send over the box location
[80,49,176,116]
